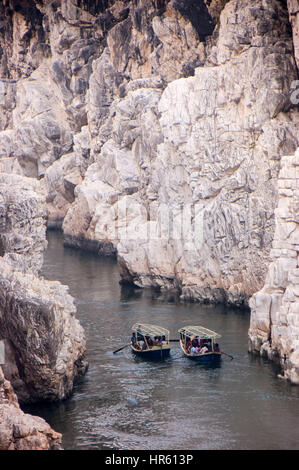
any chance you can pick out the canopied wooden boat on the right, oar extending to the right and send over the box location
[178,326,221,364]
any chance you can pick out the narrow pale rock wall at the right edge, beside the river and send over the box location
[249,150,299,384]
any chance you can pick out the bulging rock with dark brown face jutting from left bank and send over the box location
[0,259,87,403]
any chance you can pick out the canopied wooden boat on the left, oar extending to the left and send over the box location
[131,323,170,360]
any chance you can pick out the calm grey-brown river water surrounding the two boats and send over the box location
[26,232,299,450]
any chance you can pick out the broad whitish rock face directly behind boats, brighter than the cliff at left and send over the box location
[63,0,298,305]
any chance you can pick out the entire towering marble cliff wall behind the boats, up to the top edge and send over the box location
[0,0,299,381]
